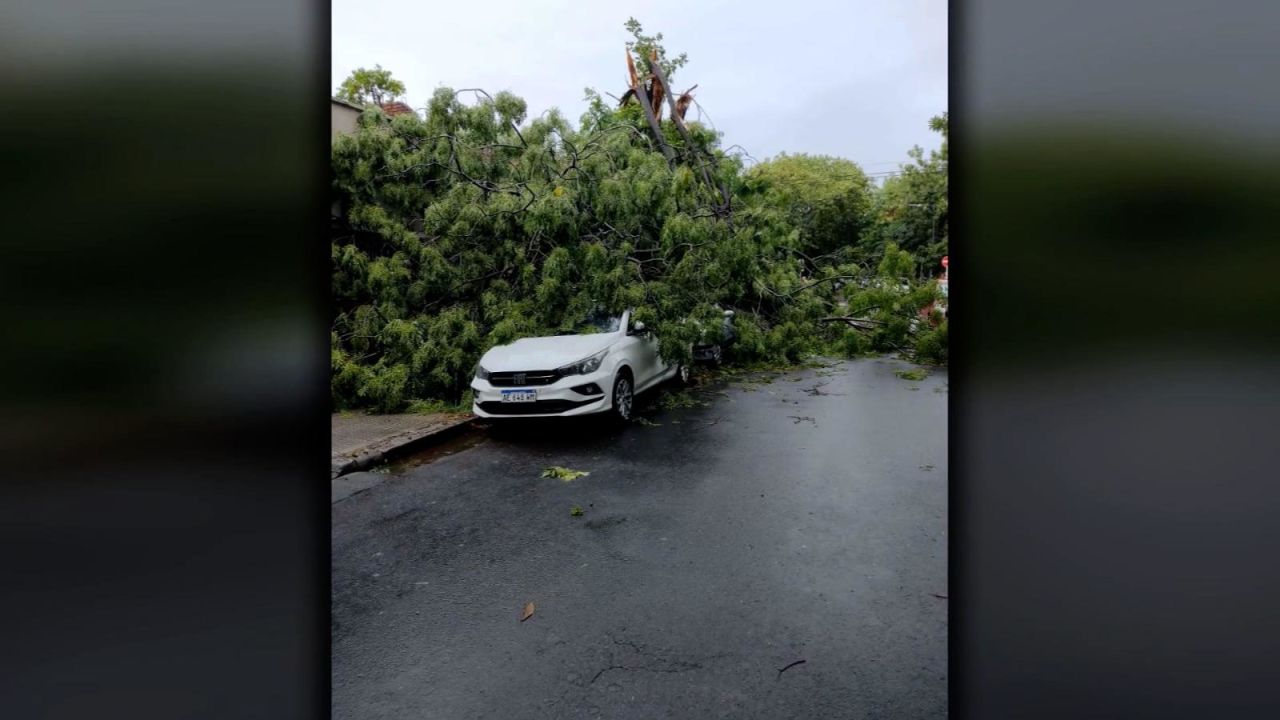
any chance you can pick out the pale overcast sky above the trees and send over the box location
[333,0,947,173]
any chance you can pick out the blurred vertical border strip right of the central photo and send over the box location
[950,0,1280,719]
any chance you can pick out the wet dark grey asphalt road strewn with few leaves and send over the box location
[332,360,947,720]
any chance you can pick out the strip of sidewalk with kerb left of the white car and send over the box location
[329,413,475,479]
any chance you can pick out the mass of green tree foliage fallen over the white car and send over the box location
[330,29,945,411]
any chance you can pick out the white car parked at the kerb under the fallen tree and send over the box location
[471,310,689,420]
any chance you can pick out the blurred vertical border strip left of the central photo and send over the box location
[0,0,330,717]
